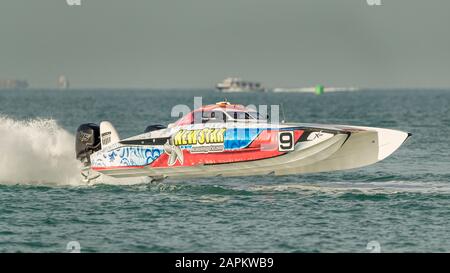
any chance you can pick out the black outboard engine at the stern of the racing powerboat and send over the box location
[75,123,100,163]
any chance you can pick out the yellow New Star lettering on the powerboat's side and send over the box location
[173,128,226,146]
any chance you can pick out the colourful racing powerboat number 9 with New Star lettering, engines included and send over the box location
[75,102,411,181]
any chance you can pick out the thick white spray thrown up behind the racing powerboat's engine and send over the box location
[0,116,80,185]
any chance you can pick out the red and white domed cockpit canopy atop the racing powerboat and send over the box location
[174,102,267,126]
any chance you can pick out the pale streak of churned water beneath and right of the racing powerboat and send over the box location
[90,177,450,199]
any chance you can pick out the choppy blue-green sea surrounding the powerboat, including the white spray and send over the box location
[0,90,450,252]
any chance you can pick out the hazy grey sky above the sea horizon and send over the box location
[0,0,450,88]
